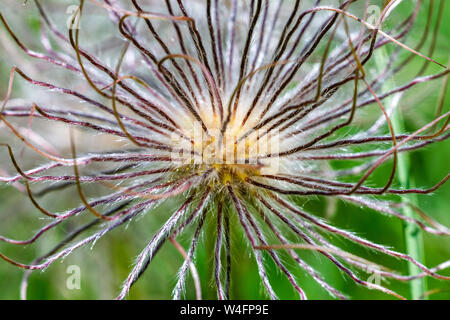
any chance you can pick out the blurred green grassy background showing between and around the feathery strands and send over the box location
[0,0,450,299]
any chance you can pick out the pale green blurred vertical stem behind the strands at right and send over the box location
[376,48,427,300]
